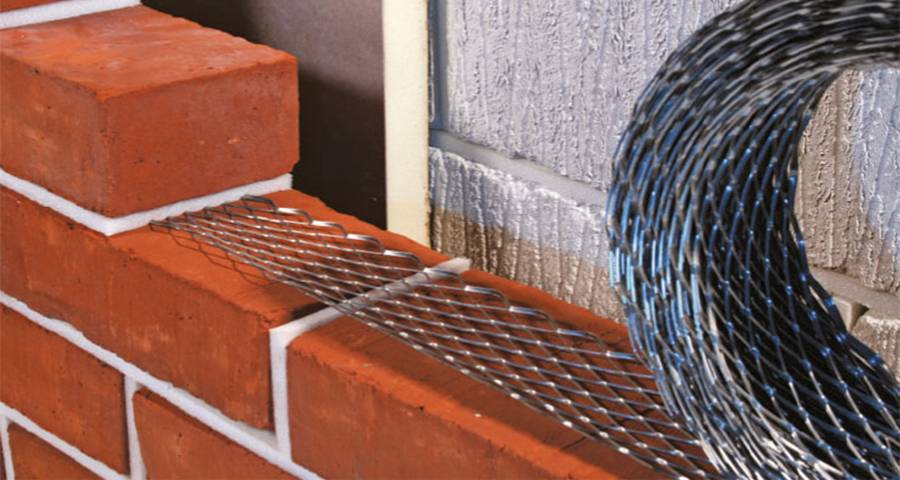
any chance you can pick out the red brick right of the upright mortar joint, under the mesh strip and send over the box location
[288,319,655,478]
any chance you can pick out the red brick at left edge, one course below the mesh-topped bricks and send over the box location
[0,306,128,473]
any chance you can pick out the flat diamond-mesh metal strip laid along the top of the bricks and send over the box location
[155,197,715,477]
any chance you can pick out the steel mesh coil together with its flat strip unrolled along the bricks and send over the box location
[155,0,900,478]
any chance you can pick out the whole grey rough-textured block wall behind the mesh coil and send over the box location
[430,0,900,344]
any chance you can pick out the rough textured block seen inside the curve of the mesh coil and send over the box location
[797,68,900,298]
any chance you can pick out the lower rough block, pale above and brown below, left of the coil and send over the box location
[430,148,622,320]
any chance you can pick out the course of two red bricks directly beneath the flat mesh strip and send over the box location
[0,179,676,478]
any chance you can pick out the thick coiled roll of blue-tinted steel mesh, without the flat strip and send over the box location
[608,0,900,478]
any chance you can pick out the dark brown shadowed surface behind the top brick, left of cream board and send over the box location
[144,0,386,228]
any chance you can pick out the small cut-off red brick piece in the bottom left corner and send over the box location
[9,425,100,480]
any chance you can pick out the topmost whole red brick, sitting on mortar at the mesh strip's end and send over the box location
[0,7,299,216]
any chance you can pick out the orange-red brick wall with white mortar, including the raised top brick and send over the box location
[0,2,655,479]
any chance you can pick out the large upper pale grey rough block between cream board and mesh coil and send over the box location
[439,0,737,190]
